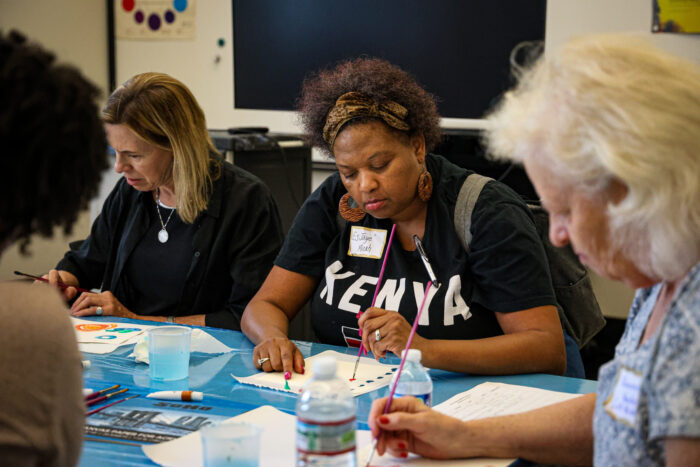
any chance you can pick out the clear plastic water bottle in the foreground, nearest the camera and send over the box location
[296,357,357,467]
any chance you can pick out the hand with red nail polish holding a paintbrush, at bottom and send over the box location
[367,397,474,459]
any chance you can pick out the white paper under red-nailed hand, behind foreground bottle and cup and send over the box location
[141,406,512,467]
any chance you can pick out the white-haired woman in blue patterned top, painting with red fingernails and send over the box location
[370,35,700,466]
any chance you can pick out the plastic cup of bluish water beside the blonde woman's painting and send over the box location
[148,326,192,381]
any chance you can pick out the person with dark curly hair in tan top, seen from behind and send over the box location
[0,31,107,466]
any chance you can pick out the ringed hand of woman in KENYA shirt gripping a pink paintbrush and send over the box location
[358,308,424,360]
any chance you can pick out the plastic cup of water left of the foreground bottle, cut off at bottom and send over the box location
[199,423,263,467]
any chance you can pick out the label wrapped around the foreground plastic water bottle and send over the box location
[297,417,355,459]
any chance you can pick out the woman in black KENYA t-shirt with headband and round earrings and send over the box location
[242,58,580,380]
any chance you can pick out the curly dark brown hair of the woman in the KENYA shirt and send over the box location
[297,58,442,155]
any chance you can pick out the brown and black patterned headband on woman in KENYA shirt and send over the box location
[323,91,411,150]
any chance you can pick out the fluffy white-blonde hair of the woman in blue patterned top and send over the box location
[486,34,700,280]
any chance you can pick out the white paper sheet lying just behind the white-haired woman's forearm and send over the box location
[433,383,582,421]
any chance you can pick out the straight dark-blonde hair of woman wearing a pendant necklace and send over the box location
[102,73,221,223]
